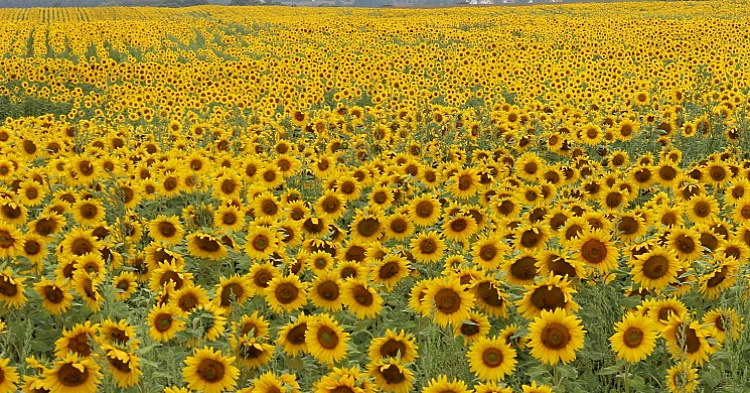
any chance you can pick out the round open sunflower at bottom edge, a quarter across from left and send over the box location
[182,347,240,393]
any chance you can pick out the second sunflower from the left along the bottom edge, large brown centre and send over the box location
[43,354,104,393]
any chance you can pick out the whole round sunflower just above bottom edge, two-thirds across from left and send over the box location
[466,337,517,382]
